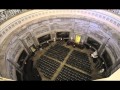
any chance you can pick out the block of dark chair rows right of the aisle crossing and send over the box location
[67,50,92,73]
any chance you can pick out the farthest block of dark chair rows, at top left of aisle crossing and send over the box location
[45,44,70,61]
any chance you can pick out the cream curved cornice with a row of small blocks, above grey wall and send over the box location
[0,10,120,43]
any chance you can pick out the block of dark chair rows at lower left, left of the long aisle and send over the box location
[37,56,60,79]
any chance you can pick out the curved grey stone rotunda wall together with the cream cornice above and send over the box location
[0,10,120,80]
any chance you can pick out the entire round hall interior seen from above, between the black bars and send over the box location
[0,9,120,81]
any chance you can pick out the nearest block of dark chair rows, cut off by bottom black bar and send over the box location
[56,66,92,81]
